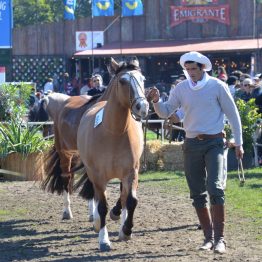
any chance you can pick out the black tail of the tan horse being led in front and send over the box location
[72,163,95,200]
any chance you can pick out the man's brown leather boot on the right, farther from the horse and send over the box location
[211,205,226,254]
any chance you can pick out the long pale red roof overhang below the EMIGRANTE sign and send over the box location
[74,38,262,58]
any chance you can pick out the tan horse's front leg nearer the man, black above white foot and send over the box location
[119,173,138,241]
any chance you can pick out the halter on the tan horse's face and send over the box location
[120,70,149,121]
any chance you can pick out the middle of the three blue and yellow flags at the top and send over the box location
[92,0,114,16]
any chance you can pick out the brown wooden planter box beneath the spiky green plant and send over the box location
[1,153,44,181]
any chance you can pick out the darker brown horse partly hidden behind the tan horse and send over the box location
[42,93,102,221]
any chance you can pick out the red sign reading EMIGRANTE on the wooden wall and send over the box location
[170,5,230,27]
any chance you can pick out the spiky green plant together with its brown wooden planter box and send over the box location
[0,120,52,180]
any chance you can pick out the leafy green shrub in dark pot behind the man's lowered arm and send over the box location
[225,98,261,170]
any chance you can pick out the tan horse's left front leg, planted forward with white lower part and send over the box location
[94,186,111,252]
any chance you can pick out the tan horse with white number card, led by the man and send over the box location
[77,59,149,251]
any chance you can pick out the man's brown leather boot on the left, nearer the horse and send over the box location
[196,207,214,250]
